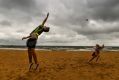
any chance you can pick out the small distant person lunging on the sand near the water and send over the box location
[89,44,104,62]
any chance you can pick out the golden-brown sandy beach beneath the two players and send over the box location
[0,49,119,80]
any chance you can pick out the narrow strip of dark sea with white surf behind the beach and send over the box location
[0,45,119,51]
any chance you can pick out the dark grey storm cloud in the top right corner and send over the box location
[87,0,119,21]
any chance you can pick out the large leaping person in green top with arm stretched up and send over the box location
[22,13,50,70]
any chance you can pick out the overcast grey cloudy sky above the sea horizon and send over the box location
[0,0,119,46]
